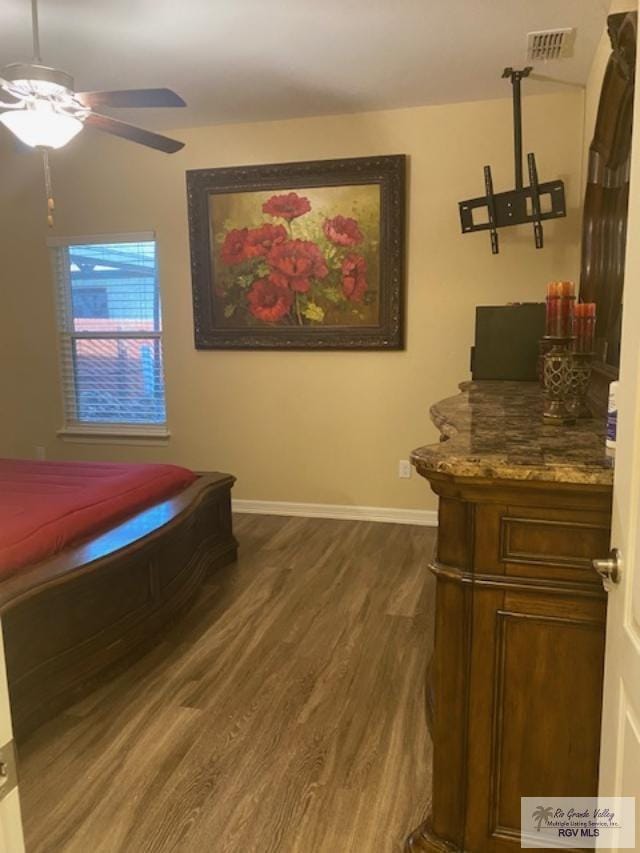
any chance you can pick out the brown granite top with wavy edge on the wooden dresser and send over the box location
[411,381,613,486]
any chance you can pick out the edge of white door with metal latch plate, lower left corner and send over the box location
[0,624,24,853]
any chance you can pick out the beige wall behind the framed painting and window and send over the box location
[0,89,584,509]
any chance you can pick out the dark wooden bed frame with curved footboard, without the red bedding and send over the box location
[0,473,237,740]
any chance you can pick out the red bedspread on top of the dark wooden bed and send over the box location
[0,459,196,574]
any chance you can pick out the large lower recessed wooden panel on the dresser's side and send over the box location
[465,584,605,853]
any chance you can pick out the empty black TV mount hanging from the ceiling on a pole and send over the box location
[459,66,567,255]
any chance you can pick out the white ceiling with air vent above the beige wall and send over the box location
[0,0,609,128]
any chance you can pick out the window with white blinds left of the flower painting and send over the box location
[51,234,166,435]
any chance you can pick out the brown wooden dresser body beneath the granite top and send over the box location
[407,471,611,853]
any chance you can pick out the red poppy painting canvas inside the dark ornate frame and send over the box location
[215,186,379,328]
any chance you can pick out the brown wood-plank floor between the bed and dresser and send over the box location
[19,515,435,853]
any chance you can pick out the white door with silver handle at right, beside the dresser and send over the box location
[600,23,640,844]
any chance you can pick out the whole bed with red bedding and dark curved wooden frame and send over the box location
[0,460,237,740]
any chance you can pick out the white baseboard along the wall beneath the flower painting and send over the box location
[232,498,438,527]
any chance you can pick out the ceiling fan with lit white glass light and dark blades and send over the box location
[0,0,186,154]
